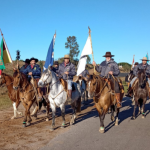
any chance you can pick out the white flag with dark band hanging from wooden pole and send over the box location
[77,35,93,76]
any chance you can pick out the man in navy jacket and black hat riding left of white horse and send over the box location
[22,57,42,99]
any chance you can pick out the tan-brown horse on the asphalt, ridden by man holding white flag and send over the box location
[87,75,124,133]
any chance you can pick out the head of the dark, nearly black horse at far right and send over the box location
[138,69,146,87]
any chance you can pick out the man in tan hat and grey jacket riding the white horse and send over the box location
[58,55,76,101]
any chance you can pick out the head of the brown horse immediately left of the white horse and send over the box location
[13,69,22,90]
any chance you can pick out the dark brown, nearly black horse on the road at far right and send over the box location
[132,69,149,119]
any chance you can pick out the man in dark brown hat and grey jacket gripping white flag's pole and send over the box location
[93,52,121,108]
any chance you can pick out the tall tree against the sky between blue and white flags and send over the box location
[65,36,80,61]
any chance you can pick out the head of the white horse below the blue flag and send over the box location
[38,66,52,87]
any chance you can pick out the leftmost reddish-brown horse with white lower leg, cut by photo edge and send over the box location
[0,73,22,119]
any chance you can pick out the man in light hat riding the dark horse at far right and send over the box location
[126,57,150,97]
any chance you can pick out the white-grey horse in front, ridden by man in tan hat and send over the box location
[38,67,81,130]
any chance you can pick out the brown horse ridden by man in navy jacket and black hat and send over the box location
[13,70,38,127]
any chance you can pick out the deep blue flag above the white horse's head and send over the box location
[43,34,56,69]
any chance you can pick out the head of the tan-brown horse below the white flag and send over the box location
[87,74,98,98]
